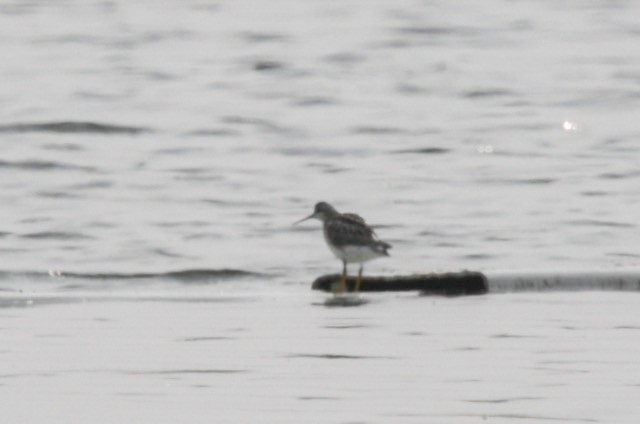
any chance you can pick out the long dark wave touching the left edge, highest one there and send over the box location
[0,121,150,134]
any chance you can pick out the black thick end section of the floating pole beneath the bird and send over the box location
[311,271,487,296]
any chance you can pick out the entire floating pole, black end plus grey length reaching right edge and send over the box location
[311,270,640,296]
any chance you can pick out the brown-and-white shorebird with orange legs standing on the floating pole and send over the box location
[294,202,391,293]
